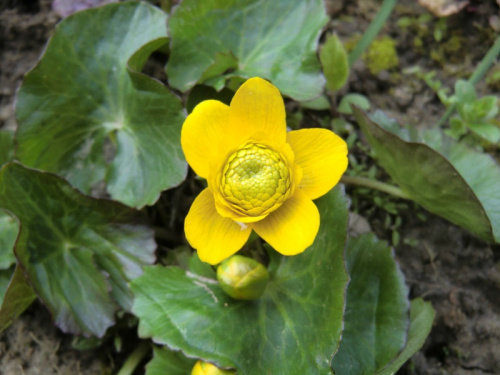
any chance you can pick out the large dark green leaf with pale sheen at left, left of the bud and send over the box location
[0,162,156,337]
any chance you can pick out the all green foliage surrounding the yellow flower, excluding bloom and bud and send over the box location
[0,0,478,375]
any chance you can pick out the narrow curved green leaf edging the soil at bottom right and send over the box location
[378,298,435,375]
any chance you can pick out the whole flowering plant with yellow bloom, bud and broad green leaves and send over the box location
[0,0,500,375]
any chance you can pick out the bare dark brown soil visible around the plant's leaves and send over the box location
[0,0,500,375]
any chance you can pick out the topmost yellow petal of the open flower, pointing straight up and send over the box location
[231,78,286,145]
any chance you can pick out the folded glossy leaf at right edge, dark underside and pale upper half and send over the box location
[354,108,500,242]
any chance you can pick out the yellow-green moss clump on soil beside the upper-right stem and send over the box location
[363,36,399,74]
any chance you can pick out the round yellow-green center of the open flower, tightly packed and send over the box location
[221,143,292,216]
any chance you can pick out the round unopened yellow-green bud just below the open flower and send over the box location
[217,255,269,300]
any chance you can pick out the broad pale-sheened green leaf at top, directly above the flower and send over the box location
[167,0,328,101]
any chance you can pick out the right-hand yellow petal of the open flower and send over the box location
[287,129,347,199]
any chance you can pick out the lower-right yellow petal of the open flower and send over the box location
[251,189,319,255]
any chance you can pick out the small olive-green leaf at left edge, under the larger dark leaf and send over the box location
[0,266,36,332]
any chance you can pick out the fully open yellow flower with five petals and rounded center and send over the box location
[181,78,347,264]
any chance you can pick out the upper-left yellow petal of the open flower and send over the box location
[181,100,233,178]
